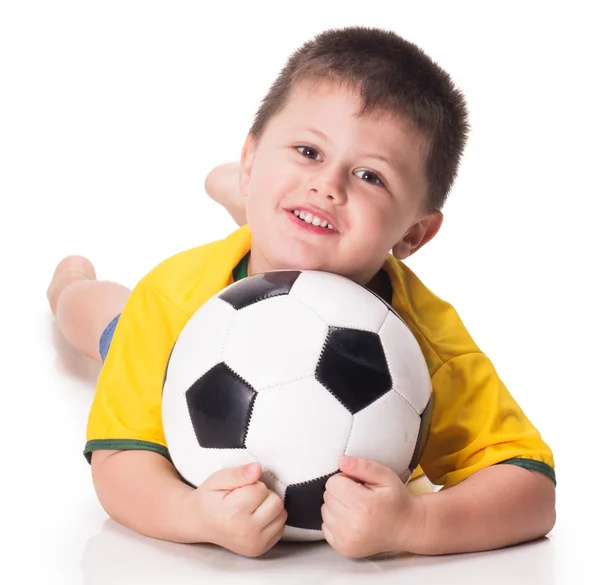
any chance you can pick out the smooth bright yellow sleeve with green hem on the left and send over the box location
[84,280,188,461]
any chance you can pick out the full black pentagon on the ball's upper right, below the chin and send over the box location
[315,327,392,414]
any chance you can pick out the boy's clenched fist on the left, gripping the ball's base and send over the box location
[186,463,287,557]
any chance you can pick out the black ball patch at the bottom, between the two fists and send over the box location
[284,471,338,530]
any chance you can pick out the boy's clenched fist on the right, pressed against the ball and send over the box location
[321,456,424,558]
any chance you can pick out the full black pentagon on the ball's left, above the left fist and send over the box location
[185,363,256,449]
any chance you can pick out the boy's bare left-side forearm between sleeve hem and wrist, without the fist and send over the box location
[92,451,197,542]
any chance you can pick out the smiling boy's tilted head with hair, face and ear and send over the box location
[240,28,468,284]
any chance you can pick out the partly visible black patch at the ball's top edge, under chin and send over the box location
[219,270,300,311]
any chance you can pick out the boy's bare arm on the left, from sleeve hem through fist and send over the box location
[92,450,287,557]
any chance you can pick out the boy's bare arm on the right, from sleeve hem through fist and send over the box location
[321,457,555,558]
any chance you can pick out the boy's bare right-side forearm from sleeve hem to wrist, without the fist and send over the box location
[412,464,556,555]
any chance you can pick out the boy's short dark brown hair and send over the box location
[250,27,469,210]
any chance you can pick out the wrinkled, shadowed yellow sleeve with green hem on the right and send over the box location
[421,352,556,487]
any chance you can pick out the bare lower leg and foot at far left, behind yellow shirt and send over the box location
[47,256,131,362]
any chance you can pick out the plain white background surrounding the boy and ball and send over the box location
[0,0,600,585]
